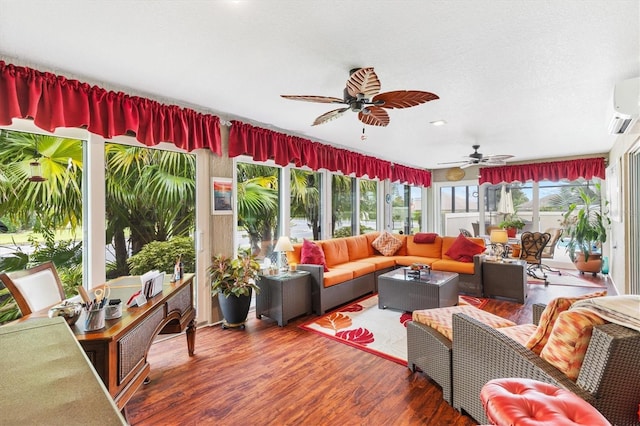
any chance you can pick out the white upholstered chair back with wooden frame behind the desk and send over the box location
[0,262,65,316]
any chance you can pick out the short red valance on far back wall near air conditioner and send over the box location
[479,158,605,185]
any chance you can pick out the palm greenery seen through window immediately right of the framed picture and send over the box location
[236,162,281,258]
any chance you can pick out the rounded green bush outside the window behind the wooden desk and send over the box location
[127,237,196,275]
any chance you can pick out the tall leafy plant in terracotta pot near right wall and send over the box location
[562,184,611,276]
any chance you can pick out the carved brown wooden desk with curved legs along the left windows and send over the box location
[23,274,196,409]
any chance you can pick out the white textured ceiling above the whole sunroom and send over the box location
[0,0,640,169]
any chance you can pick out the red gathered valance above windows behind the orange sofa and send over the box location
[229,121,431,186]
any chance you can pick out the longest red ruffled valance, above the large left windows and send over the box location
[0,61,222,155]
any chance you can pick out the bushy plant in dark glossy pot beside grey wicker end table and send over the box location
[208,250,260,328]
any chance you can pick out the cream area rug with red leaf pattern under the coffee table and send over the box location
[300,295,488,366]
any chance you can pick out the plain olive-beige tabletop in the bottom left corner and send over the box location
[0,317,127,425]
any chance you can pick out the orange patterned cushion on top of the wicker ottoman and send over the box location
[412,305,516,340]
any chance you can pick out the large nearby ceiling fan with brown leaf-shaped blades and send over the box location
[280,67,439,126]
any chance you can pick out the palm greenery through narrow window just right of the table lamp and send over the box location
[290,169,322,242]
